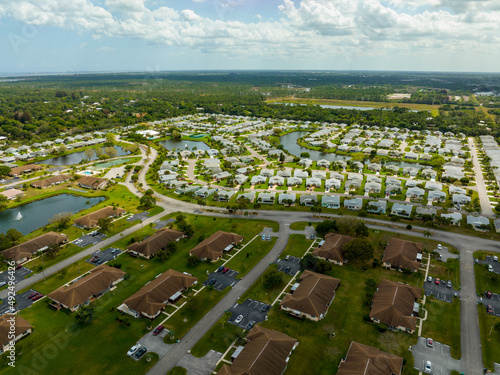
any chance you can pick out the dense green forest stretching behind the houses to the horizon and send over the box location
[0,72,500,143]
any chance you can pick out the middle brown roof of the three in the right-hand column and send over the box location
[370,280,422,330]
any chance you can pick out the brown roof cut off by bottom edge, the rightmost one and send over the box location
[337,341,403,375]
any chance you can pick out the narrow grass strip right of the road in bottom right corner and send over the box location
[478,304,500,370]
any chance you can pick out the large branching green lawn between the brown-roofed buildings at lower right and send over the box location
[261,264,421,375]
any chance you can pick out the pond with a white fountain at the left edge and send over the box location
[0,194,105,234]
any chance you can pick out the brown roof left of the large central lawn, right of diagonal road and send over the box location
[281,270,340,318]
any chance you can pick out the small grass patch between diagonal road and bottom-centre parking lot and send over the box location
[191,312,245,357]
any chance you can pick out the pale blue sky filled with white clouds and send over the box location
[0,0,500,73]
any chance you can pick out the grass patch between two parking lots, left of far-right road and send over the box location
[422,298,461,359]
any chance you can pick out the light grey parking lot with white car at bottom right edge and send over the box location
[411,337,462,375]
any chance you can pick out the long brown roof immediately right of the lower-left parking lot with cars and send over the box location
[48,264,126,308]
